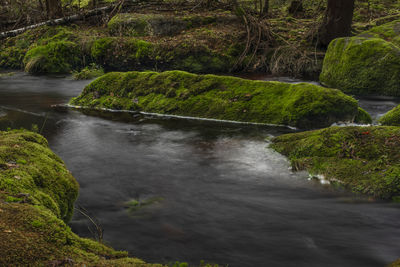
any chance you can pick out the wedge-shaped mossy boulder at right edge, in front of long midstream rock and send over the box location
[271,126,400,199]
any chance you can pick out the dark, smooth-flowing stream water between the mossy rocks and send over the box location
[0,73,400,267]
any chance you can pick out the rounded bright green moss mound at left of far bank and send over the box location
[24,41,81,74]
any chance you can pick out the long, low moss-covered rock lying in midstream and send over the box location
[71,71,358,128]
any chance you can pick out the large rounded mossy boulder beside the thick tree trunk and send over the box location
[320,37,400,96]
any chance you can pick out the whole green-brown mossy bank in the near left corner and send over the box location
[0,130,161,266]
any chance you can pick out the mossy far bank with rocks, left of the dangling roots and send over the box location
[0,12,243,74]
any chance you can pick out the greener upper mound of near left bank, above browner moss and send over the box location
[0,131,78,221]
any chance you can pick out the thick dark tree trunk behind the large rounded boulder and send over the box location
[319,0,355,46]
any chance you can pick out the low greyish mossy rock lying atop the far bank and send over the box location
[107,13,217,37]
